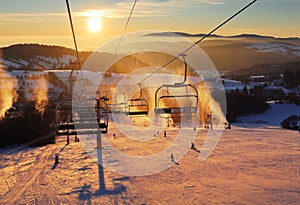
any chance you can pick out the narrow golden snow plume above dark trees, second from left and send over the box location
[33,76,48,115]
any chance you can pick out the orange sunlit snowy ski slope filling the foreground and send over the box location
[0,121,300,204]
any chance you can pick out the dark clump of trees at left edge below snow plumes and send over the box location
[0,101,55,147]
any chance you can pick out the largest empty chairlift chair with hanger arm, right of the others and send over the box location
[154,54,198,116]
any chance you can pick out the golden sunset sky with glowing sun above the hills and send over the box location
[0,0,300,51]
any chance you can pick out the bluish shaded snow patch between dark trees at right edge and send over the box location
[237,103,300,127]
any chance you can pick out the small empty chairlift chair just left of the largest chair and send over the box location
[125,83,149,116]
